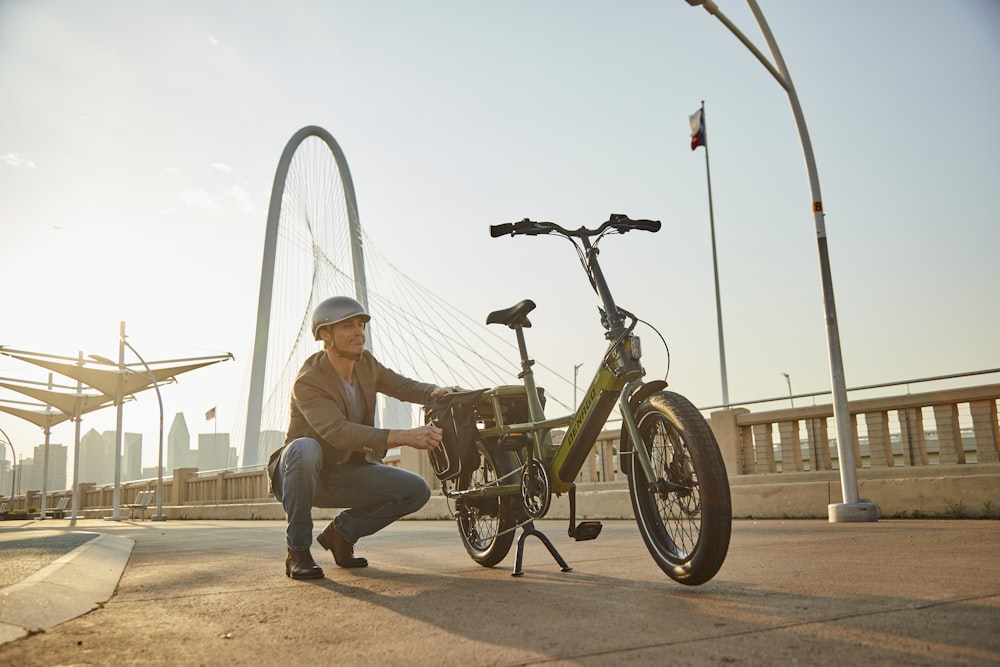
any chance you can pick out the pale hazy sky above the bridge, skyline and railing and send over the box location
[0,0,1000,466]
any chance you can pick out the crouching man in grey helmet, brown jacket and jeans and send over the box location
[267,296,457,579]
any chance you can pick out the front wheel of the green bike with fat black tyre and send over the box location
[628,391,733,586]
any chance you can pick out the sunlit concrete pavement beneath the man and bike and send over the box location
[0,520,1000,666]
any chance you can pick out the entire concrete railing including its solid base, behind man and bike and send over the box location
[10,384,1000,519]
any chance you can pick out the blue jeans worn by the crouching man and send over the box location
[273,438,431,551]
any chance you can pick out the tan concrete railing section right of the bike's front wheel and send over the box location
[711,384,1000,518]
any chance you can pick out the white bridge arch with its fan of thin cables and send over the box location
[234,126,573,467]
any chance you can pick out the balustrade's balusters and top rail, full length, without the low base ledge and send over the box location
[9,384,1000,517]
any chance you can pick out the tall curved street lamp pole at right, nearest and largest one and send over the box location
[686,0,879,523]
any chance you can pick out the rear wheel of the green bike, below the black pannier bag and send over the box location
[455,447,520,567]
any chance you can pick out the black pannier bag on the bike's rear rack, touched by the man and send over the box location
[424,389,486,482]
